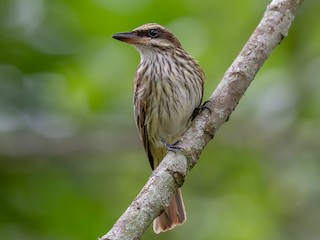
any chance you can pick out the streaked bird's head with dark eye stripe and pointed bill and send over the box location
[112,23,181,53]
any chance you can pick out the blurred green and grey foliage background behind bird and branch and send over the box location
[0,0,320,240]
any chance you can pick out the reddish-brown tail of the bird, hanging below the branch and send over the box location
[153,188,187,234]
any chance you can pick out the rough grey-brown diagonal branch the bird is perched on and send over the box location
[100,0,303,240]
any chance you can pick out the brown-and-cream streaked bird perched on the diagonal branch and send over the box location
[112,23,205,234]
